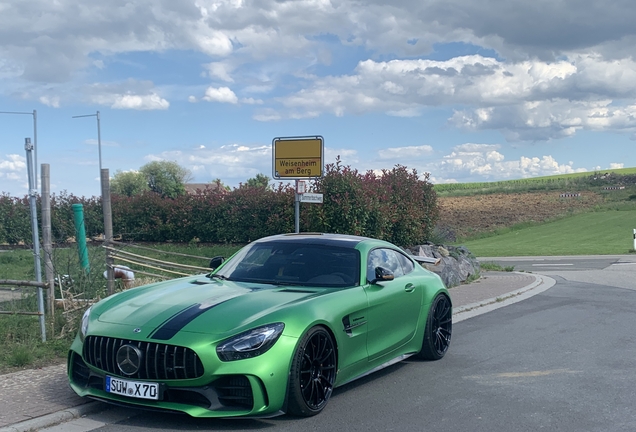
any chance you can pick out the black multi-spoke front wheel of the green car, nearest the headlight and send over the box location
[287,327,337,417]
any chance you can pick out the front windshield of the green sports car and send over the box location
[216,242,360,287]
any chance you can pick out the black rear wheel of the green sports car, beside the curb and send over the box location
[418,294,453,360]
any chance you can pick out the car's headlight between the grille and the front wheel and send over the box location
[216,323,285,361]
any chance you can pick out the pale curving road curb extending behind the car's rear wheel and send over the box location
[452,272,556,322]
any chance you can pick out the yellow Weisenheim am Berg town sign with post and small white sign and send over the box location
[272,135,325,233]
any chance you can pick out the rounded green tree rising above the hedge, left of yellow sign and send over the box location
[139,161,192,198]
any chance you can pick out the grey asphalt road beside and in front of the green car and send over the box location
[41,257,636,432]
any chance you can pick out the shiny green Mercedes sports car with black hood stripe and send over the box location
[68,233,452,417]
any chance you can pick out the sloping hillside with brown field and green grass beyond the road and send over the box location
[435,168,636,256]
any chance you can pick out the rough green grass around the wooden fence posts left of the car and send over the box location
[0,243,245,373]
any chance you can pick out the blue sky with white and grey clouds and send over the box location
[0,0,636,196]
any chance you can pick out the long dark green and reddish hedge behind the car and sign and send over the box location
[0,160,438,246]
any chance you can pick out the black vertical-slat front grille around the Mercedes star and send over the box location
[83,336,203,380]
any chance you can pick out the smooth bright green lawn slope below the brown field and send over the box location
[454,209,636,257]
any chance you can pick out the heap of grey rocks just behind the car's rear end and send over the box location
[408,243,480,288]
